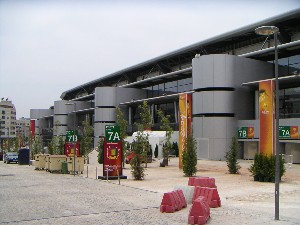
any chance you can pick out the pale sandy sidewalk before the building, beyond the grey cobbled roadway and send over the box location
[81,152,300,224]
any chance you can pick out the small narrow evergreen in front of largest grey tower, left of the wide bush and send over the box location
[225,136,241,174]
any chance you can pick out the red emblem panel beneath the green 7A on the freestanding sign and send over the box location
[103,141,122,177]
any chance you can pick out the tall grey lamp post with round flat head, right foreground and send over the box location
[255,26,280,220]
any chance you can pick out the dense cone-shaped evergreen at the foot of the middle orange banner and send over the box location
[182,133,197,177]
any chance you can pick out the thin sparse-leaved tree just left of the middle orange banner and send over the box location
[157,110,173,166]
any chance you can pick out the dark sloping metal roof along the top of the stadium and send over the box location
[61,9,300,100]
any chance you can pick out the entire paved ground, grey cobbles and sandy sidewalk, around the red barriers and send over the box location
[0,152,300,225]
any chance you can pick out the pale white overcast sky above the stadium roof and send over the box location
[0,0,300,118]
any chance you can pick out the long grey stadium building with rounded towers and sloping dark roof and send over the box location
[30,10,300,163]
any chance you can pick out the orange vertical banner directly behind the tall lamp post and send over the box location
[259,80,278,155]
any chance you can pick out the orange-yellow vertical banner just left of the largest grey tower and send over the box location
[179,94,192,169]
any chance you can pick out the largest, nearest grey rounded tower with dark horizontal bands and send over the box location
[193,55,272,160]
